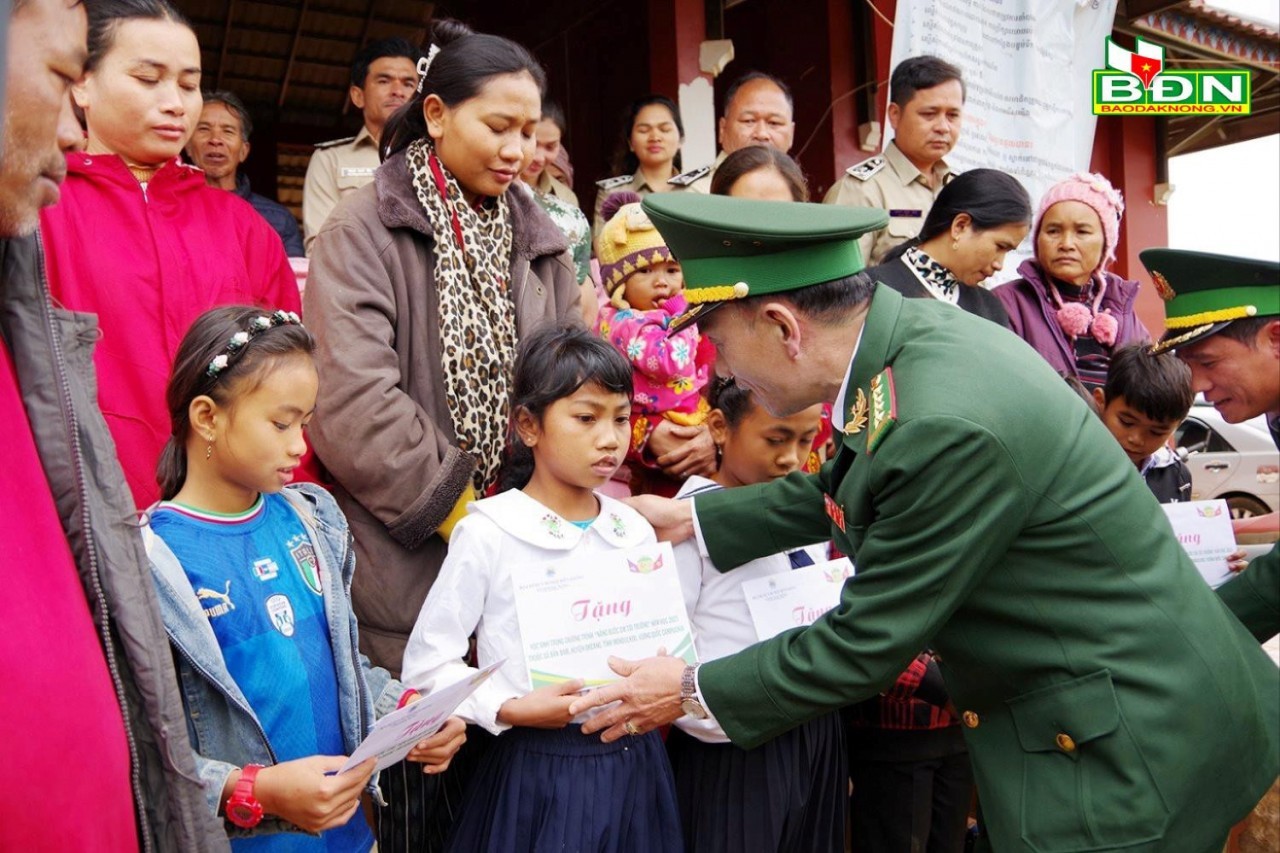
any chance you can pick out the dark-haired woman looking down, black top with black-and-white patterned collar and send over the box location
[867,169,1032,327]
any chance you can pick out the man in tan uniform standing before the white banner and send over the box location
[823,56,965,266]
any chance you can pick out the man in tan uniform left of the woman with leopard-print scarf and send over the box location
[302,38,422,254]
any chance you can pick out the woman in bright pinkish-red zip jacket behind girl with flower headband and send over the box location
[41,0,298,507]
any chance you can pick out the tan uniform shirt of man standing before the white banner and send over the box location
[822,141,955,266]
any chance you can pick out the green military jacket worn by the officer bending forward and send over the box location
[695,286,1280,853]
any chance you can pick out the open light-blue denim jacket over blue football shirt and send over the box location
[143,483,404,838]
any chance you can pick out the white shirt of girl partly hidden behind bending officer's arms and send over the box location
[675,475,827,743]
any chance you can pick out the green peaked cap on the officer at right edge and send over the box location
[1138,248,1280,352]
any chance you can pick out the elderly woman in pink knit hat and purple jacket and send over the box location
[995,173,1151,388]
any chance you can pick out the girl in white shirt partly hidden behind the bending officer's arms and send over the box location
[667,379,849,853]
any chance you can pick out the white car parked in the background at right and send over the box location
[1174,403,1280,519]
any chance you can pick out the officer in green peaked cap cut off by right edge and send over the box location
[1139,248,1280,640]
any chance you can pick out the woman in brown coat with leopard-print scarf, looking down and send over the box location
[306,20,581,852]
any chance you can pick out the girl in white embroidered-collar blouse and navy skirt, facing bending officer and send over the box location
[402,327,684,853]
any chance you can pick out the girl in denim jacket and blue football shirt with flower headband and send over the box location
[143,306,465,853]
